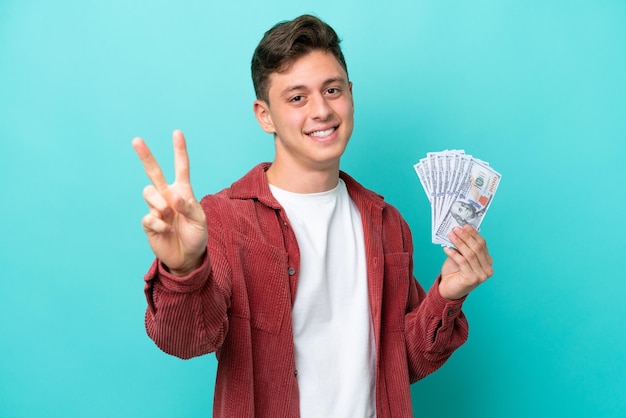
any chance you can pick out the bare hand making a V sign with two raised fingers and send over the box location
[133,130,208,277]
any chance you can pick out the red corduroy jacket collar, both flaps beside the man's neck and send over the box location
[229,162,385,209]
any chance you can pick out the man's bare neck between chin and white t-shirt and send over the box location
[266,162,339,193]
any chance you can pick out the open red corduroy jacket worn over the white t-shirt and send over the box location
[145,163,468,418]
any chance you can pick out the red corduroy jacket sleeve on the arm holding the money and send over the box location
[402,216,469,383]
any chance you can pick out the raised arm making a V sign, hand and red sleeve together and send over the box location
[133,131,230,358]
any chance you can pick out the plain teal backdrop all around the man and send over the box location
[0,0,626,418]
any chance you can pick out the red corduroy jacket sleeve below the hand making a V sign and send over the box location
[144,198,232,359]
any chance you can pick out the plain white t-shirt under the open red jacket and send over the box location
[270,179,376,418]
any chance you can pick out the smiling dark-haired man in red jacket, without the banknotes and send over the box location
[133,15,493,418]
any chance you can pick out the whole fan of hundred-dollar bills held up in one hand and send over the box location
[413,150,502,247]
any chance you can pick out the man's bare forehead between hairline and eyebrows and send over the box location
[268,50,348,96]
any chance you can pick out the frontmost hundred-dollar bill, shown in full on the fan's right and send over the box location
[433,159,502,246]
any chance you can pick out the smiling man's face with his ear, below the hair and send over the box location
[254,51,354,173]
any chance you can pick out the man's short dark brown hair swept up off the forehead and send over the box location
[251,15,348,103]
